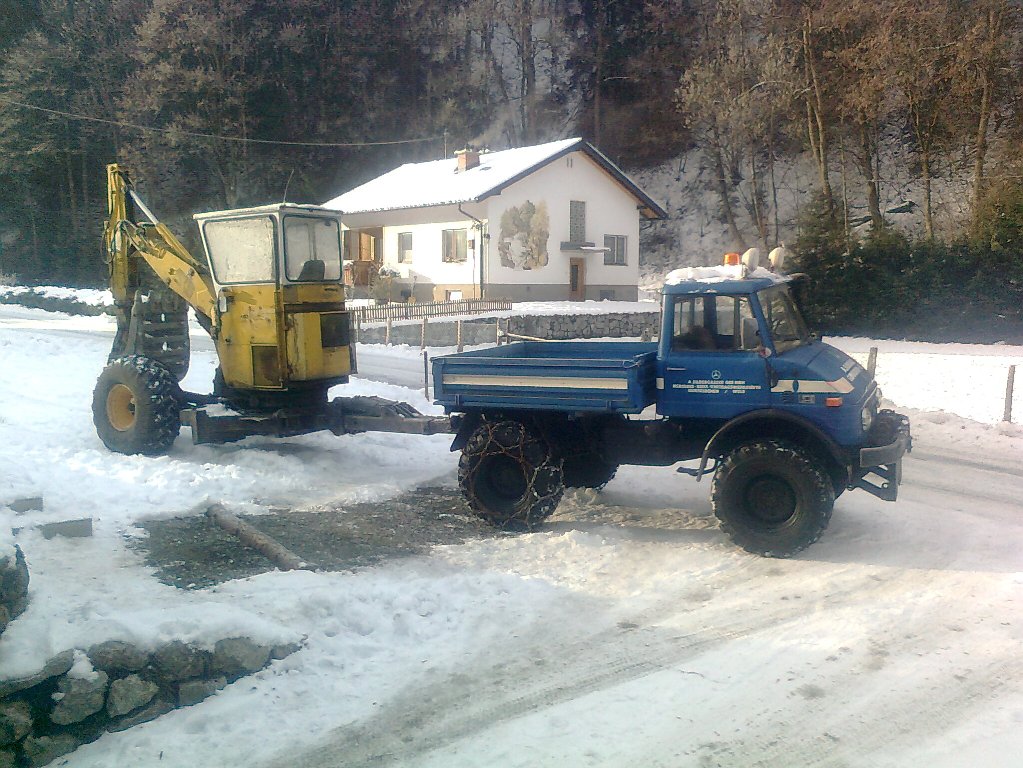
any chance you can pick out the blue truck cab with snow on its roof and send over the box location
[657,268,881,448]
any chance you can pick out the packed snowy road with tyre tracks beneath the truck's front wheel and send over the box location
[266,443,1023,768]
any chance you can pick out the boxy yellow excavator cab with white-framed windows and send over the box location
[194,204,353,405]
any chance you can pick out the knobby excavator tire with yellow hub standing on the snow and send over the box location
[92,355,181,456]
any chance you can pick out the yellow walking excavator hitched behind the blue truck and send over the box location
[92,164,451,455]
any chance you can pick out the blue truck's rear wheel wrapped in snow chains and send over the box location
[458,420,565,530]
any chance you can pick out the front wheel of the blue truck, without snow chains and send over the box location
[711,441,835,557]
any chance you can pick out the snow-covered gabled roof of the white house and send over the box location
[323,138,666,215]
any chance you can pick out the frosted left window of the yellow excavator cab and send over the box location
[203,216,275,285]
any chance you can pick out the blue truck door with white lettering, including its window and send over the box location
[658,295,770,418]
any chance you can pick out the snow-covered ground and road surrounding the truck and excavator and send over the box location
[0,306,1023,768]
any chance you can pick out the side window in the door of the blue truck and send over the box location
[671,296,760,351]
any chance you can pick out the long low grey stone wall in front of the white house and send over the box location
[358,310,660,347]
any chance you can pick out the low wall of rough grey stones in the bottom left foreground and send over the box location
[0,637,299,768]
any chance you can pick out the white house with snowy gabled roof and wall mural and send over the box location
[323,139,667,302]
